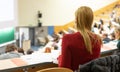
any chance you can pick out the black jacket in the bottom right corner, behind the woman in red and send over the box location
[76,55,120,72]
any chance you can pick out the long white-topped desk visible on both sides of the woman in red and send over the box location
[0,41,116,72]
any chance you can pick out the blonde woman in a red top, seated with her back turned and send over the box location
[58,6,102,71]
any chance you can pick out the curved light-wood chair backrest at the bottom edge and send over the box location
[37,67,73,72]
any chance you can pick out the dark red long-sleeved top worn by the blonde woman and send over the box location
[58,32,101,71]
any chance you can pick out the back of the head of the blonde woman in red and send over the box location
[75,6,94,30]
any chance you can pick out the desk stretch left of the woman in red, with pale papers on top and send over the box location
[0,51,57,72]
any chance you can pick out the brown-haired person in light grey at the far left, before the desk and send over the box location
[0,44,21,60]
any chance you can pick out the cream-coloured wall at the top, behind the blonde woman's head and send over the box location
[18,0,117,26]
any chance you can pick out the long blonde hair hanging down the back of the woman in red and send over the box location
[75,6,94,54]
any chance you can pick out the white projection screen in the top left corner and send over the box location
[0,0,17,29]
